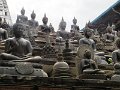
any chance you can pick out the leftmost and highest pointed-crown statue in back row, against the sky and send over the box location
[16,8,28,24]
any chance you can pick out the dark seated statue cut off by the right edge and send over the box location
[112,38,120,63]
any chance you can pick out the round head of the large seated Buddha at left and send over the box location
[13,23,24,38]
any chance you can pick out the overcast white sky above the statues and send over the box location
[7,0,118,31]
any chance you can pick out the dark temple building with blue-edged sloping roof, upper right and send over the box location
[90,0,120,32]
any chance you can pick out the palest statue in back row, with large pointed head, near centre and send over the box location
[57,18,69,40]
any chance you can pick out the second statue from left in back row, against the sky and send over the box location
[28,11,39,28]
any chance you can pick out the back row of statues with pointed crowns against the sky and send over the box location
[16,8,80,39]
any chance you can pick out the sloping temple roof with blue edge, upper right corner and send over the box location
[91,0,120,25]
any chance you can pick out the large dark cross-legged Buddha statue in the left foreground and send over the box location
[0,23,41,61]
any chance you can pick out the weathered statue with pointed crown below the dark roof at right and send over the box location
[104,25,115,43]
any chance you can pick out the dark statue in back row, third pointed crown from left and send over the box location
[39,14,51,33]
